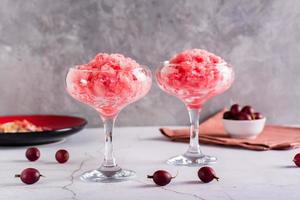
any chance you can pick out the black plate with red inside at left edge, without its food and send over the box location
[0,115,87,146]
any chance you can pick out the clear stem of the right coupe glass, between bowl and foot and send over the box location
[186,108,202,156]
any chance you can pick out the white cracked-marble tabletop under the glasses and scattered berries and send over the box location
[0,127,300,200]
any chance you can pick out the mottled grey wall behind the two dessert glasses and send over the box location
[0,0,300,126]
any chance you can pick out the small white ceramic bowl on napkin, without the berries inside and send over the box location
[223,117,266,139]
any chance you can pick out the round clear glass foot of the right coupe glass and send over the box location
[167,153,217,166]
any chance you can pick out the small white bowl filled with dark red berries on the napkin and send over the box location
[223,104,266,139]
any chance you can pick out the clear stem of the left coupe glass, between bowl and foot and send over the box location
[102,117,117,168]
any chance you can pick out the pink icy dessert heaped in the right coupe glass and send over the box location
[156,49,234,108]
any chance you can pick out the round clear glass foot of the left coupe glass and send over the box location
[80,168,135,183]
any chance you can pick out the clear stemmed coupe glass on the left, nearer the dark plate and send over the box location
[66,66,152,182]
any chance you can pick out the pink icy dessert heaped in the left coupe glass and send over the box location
[66,53,152,117]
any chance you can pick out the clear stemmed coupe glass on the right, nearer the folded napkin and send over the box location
[156,61,234,166]
